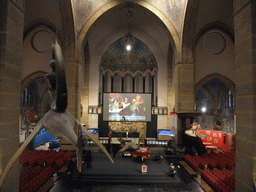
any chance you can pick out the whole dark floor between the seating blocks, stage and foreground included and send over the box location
[49,149,204,192]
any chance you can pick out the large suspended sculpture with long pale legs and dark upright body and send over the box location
[0,42,114,188]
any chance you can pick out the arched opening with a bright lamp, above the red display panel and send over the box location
[196,79,235,133]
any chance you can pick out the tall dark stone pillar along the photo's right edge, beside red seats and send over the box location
[234,0,256,191]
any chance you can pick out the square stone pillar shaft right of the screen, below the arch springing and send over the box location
[175,62,195,112]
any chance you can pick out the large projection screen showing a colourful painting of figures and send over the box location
[103,93,151,121]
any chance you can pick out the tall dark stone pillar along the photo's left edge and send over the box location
[0,0,24,192]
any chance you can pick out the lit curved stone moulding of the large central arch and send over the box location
[76,0,181,60]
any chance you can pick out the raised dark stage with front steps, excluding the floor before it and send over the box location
[74,152,183,184]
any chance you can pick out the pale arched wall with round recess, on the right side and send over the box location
[195,29,235,83]
